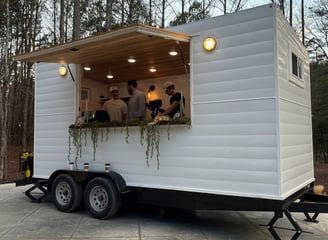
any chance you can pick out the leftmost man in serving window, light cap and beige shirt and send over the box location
[104,86,128,122]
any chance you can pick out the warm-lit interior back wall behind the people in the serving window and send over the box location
[79,70,190,123]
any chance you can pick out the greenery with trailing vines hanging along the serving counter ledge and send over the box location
[68,117,191,169]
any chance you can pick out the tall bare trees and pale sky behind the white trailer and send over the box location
[0,0,328,183]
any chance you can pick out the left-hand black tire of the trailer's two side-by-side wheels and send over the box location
[51,174,83,212]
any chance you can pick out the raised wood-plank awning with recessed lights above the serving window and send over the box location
[15,24,191,83]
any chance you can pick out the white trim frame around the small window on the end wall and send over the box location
[288,45,305,88]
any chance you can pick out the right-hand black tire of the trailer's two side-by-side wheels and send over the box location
[84,177,120,219]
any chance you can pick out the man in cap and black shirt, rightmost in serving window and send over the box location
[161,81,185,118]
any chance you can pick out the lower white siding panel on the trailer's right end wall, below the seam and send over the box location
[280,100,313,195]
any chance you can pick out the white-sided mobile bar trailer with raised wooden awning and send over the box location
[16,4,328,239]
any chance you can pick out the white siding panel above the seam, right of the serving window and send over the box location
[192,10,275,104]
